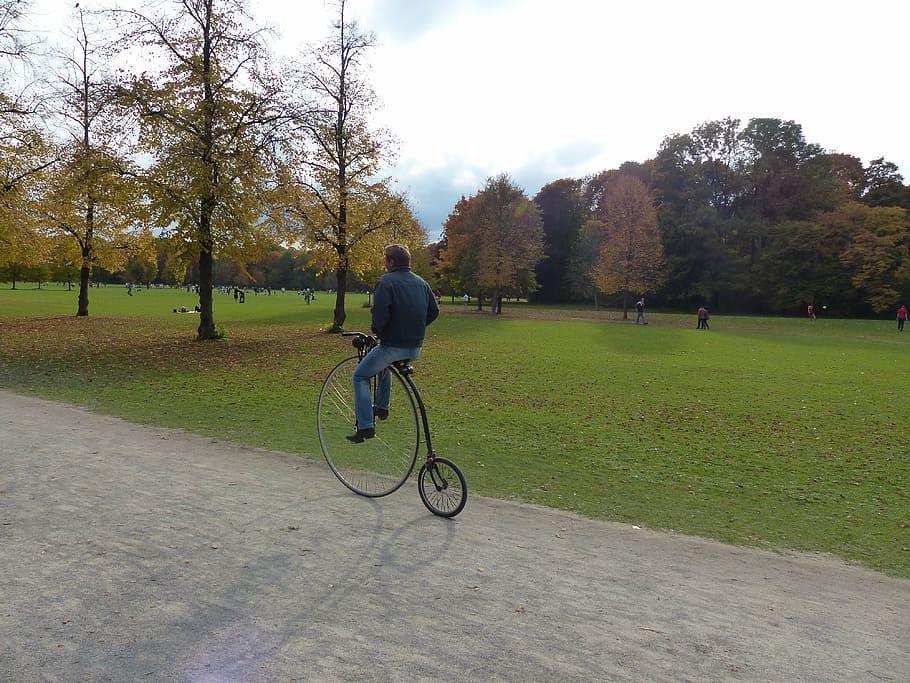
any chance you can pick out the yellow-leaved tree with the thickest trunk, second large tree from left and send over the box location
[119,0,288,340]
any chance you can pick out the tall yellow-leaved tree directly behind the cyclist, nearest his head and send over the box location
[272,0,418,330]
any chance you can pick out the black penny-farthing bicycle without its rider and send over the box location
[317,332,468,517]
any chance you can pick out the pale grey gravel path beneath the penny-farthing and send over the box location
[0,391,910,682]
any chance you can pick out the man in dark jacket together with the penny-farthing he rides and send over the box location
[317,244,467,517]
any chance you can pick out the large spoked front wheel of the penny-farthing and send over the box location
[316,356,420,498]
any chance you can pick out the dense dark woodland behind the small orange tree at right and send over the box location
[520,118,910,316]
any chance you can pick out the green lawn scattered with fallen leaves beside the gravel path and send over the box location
[0,284,910,577]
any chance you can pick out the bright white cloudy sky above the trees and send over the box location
[28,0,910,239]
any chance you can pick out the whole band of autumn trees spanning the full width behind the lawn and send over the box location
[0,0,910,324]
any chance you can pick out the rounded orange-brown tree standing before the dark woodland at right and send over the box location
[593,176,664,319]
